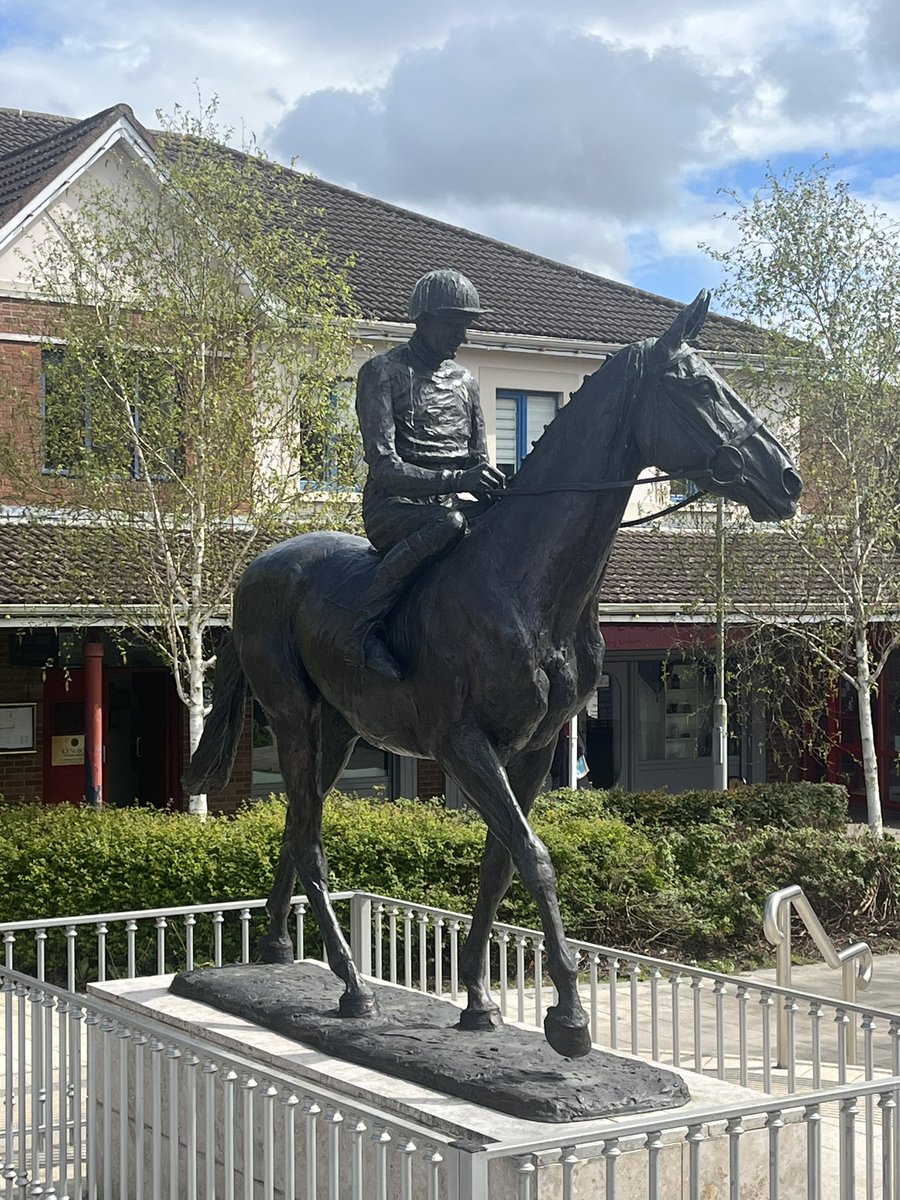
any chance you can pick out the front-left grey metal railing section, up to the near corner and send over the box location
[0,968,458,1200]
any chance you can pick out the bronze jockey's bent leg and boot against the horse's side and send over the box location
[343,509,466,679]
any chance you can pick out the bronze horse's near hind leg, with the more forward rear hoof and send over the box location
[275,700,378,1016]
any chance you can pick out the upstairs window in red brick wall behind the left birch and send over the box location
[41,350,181,479]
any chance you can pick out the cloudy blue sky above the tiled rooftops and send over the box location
[0,0,900,301]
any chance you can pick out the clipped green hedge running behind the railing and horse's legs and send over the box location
[0,785,883,971]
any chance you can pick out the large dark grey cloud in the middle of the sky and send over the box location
[271,20,745,217]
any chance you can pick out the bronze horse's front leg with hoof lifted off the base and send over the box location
[438,721,590,1058]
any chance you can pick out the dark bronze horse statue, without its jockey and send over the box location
[185,293,802,1056]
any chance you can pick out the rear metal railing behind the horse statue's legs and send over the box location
[0,892,900,1093]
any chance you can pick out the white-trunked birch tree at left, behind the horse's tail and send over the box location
[7,106,356,814]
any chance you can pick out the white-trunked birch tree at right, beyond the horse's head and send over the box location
[707,161,900,836]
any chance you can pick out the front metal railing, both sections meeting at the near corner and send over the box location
[0,968,900,1200]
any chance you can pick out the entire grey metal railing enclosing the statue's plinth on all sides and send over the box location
[0,893,900,1200]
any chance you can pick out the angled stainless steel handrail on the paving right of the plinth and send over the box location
[762,883,872,1067]
